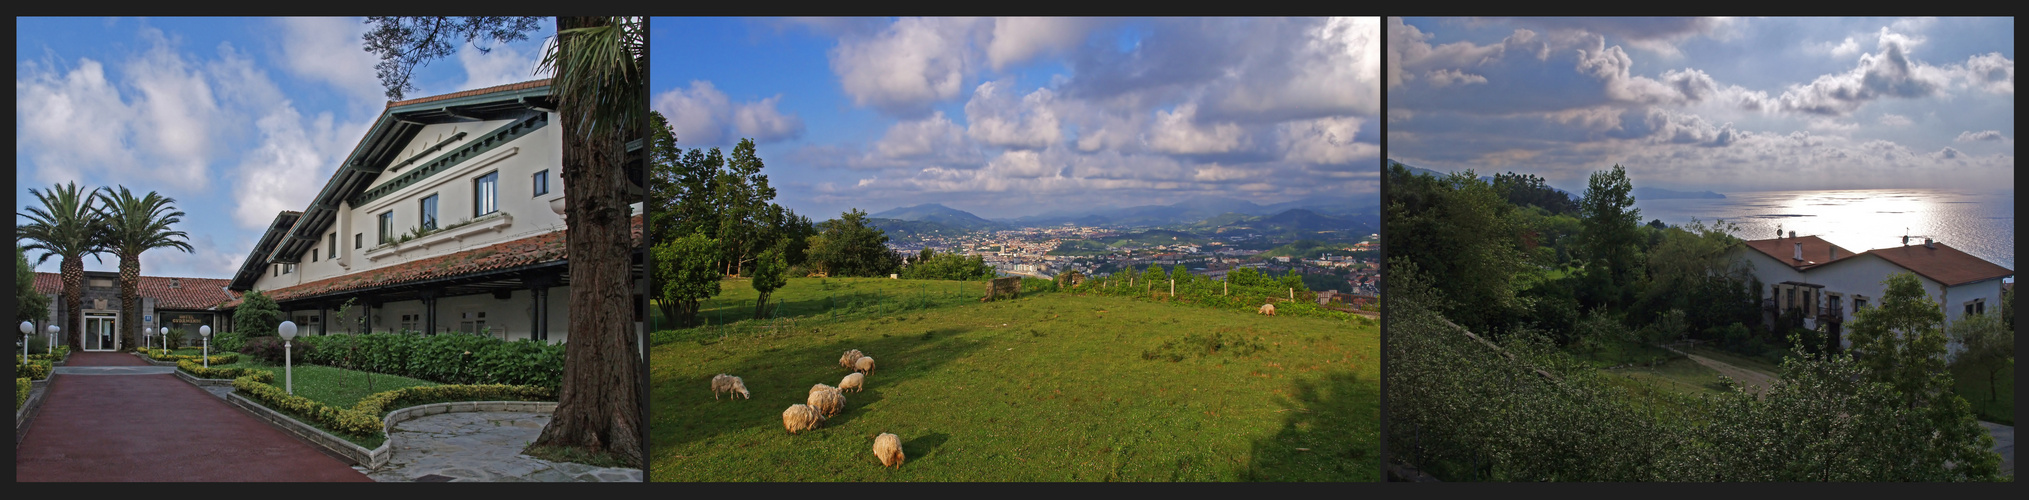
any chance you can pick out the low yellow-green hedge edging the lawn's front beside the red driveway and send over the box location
[233,376,556,437]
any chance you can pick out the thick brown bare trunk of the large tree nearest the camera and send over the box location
[534,16,643,463]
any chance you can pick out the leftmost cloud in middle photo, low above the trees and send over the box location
[653,79,803,146]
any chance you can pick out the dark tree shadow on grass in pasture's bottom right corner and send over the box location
[1240,372,1380,482]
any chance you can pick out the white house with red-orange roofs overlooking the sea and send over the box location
[1733,232,2015,346]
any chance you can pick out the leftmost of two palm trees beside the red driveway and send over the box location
[16,183,106,352]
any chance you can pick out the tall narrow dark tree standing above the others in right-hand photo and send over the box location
[1579,165,1641,305]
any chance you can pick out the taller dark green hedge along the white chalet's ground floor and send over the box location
[296,333,564,390]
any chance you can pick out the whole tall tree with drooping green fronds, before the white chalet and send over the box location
[530,16,647,469]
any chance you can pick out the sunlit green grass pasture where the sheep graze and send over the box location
[649,278,1380,482]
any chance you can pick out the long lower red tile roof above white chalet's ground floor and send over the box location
[225,215,641,307]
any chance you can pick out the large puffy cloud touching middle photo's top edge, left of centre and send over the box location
[830,18,980,118]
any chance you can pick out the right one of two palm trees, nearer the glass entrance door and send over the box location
[91,185,195,353]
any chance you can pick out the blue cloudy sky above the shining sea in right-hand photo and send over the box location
[1386,18,2015,193]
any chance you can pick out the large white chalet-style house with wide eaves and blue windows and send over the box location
[219,79,645,341]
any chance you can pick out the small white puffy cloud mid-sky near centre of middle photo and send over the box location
[966,81,1063,148]
